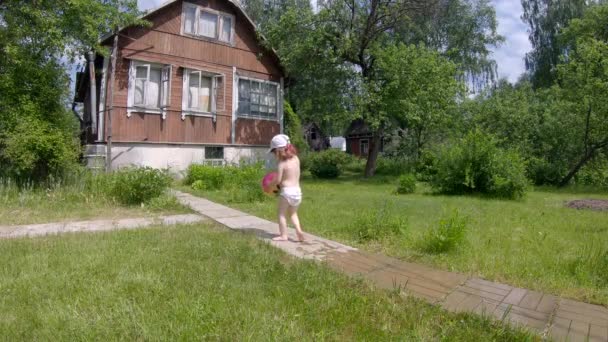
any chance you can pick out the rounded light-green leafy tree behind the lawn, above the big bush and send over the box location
[369,44,463,157]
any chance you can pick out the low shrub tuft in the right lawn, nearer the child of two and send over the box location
[351,205,408,242]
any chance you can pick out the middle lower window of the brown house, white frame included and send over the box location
[182,69,224,119]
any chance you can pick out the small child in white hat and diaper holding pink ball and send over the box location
[269,134,304,242]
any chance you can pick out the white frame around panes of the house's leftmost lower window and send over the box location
[127,60,173,120]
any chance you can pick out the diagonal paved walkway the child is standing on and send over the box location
[175,191,608,342]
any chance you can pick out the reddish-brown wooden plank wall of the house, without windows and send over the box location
[104,0,282,146]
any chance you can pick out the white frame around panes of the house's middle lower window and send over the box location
[182,67,226,122]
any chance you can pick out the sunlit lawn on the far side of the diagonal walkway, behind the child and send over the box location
[180,177,608,305]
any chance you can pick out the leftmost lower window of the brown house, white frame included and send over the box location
[127,61,172,118]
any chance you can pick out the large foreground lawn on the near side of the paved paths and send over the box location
[0,225,539,341]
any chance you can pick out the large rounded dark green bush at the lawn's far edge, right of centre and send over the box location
[431,130,527,199]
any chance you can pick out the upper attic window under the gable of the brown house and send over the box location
[182,3,234,43]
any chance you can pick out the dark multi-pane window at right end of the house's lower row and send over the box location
[238,78,278,120]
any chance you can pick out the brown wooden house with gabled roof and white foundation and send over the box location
[75,0,284,170]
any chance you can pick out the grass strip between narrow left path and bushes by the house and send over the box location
[0,184,191,225]
